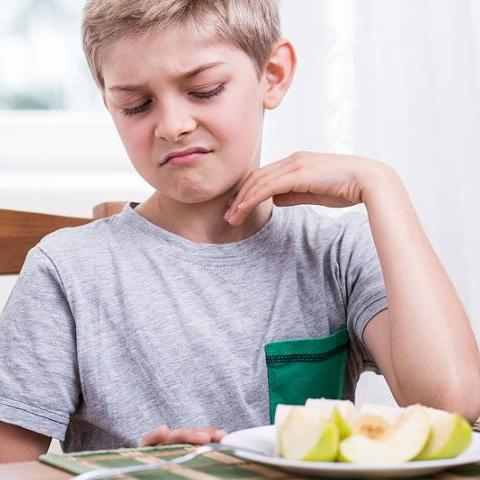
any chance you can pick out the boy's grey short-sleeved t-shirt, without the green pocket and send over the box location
[0,204,387,452]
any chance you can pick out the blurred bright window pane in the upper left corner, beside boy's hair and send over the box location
[0,0,103,110]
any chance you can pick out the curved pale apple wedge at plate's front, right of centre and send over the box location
[338,405,430,463]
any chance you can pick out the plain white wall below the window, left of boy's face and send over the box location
[0,111,151,217]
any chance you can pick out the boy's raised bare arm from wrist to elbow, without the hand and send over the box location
[362,167,480,422]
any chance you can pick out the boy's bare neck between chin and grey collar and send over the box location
[135,192,273,243]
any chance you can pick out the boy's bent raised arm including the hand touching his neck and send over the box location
[224,152,480,420]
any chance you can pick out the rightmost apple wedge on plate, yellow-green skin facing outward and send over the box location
[414,412,472,460]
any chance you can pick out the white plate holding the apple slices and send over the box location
[222,425,480,478]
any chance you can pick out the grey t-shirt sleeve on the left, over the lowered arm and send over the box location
[0,246,80,440]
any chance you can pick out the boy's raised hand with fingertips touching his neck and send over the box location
[224,152,391,225]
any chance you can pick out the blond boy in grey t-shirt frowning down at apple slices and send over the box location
[0,0,480,461]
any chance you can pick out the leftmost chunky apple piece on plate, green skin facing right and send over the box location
[280,407,339,462]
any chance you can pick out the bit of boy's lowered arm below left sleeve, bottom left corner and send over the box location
[0,422,51,463]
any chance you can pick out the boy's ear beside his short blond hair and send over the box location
[263,38,297,110]
